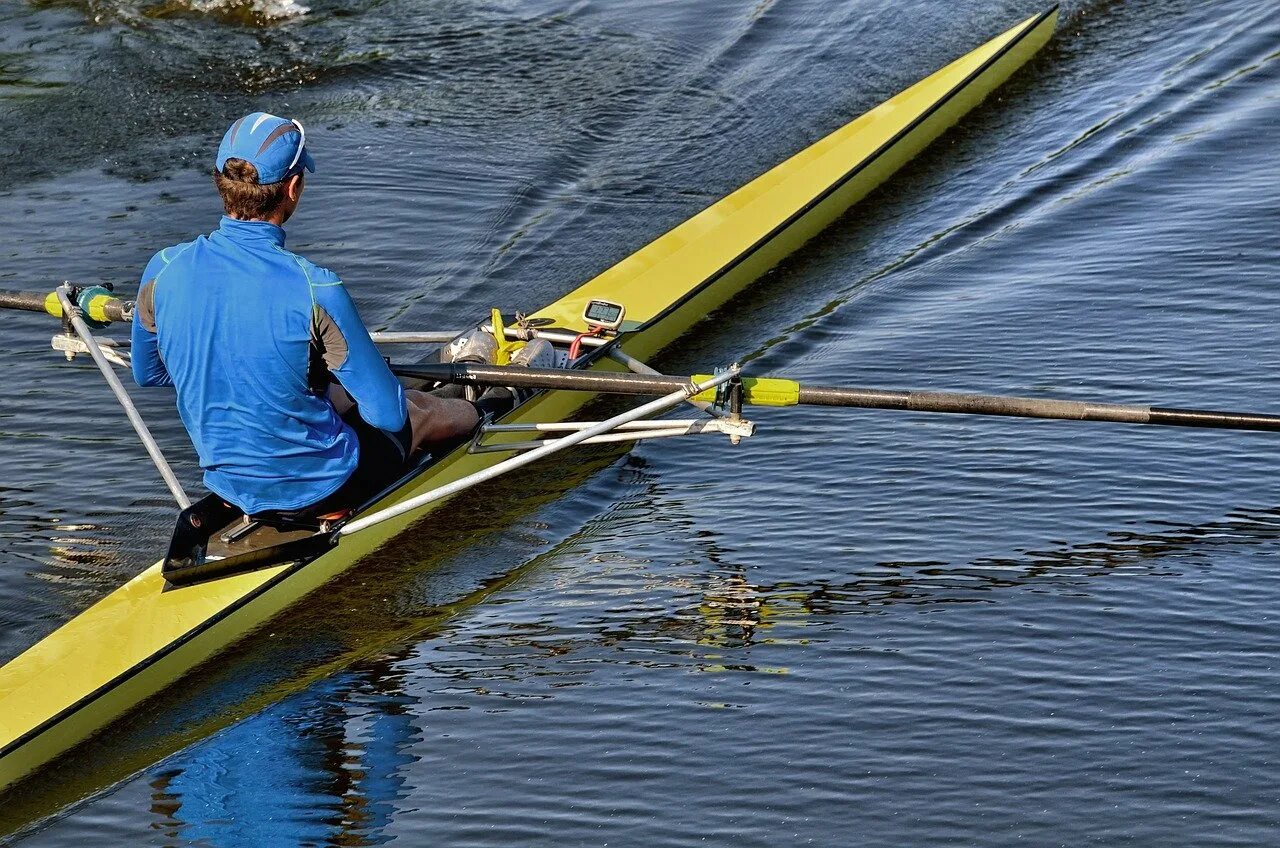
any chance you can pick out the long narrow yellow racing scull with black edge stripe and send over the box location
[0,6,1057,789]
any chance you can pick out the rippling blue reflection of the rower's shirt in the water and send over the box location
[151,675,420,848]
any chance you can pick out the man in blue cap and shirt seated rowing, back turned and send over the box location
[132,113,479,515]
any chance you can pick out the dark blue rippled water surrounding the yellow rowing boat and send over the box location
[0,0,1280,847]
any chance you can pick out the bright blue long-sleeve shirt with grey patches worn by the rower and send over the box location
[132,216,410,515]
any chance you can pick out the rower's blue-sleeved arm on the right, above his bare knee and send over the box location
[311,277,412,456]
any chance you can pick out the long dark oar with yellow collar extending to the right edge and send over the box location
[393,363,1280,432]
